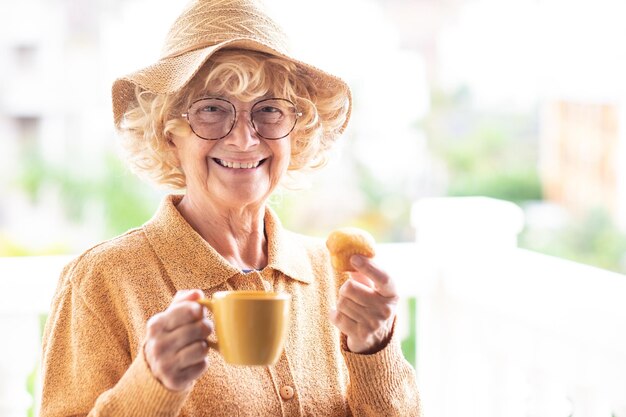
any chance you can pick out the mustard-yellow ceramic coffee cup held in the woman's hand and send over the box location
[198,291,291,365]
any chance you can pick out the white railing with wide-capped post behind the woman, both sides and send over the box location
[0,198,626,417]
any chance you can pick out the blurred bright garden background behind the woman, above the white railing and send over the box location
[0,0,626,272]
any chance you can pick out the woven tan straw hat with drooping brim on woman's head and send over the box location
[112,0,352,133]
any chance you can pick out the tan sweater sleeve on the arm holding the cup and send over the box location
[40,260,188,417]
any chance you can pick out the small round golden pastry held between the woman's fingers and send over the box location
[326,227,376,272]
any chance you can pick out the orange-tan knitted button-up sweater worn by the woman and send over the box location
[41,196,420,417]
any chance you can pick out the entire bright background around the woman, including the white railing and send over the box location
[0,0,626,417]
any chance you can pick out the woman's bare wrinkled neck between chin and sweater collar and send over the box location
[177,195,267,270]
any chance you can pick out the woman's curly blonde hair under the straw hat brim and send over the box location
[119,49,349,189]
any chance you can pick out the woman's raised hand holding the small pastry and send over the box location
[330,255,399,354]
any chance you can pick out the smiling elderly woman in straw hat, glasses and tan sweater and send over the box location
[41,0,420,417]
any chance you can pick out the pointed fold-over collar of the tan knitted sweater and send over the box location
[143,194,313,290]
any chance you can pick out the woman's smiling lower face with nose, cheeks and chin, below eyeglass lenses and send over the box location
[171,97,291,209]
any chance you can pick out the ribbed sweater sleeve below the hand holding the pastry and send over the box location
[341,329,421,417]
